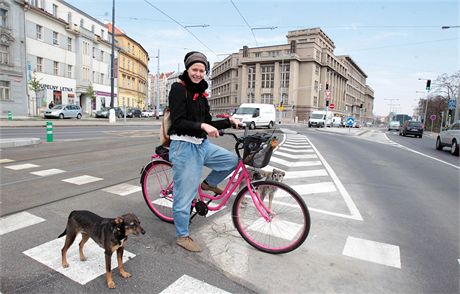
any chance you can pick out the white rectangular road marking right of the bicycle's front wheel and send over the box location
[342,236,401,268]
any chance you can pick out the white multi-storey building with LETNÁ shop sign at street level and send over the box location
[25,0,117,115]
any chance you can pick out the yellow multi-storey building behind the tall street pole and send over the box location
[107,24,149,109]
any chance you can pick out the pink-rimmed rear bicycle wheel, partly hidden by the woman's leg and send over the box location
[141,160,174,223]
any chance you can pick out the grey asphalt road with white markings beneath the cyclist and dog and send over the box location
[0,126,460,293]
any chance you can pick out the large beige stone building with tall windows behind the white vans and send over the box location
[210,28,374,120]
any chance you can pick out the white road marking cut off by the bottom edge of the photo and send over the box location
[160,275,230,294]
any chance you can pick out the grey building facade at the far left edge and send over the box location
[0,0,28,116]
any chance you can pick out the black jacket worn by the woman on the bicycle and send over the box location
[168,71,231,138]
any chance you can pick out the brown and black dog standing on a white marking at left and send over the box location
[58,210,145,289]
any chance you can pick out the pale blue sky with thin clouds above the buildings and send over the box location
[66,0,460,115]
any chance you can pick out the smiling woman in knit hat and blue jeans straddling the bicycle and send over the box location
[169,51,240,252]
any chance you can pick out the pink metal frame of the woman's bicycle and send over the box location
[147,154,272,221]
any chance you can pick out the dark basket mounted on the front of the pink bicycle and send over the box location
[243,133,278,168]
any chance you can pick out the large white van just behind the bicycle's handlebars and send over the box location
[232,103,276,129]
